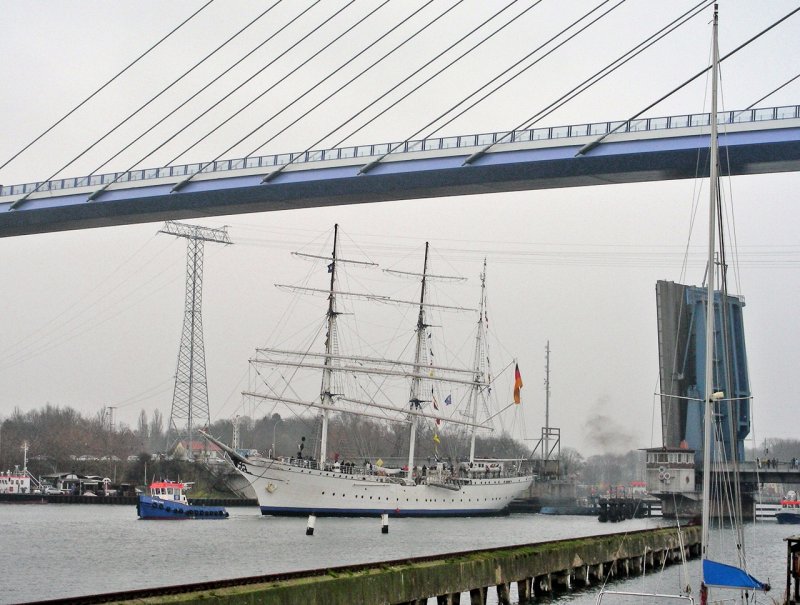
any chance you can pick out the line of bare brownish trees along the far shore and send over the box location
[6,404,800,485]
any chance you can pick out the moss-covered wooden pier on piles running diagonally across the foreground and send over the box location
[26,526,700,605]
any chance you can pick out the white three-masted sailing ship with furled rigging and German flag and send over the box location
[206,225,533,517]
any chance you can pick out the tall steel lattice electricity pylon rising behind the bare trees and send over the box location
[159,221,231,460]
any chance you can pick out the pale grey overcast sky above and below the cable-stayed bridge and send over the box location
[0,0,800,453]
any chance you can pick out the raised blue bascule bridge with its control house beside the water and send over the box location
[646,281,800,518]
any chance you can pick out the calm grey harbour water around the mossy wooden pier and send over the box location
[0,504,792,604]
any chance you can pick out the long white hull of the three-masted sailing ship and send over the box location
[237,458,533,517]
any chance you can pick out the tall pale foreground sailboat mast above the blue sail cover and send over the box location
[701,5,719,559]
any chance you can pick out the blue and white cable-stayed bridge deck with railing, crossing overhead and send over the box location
[0,105,800,237]
